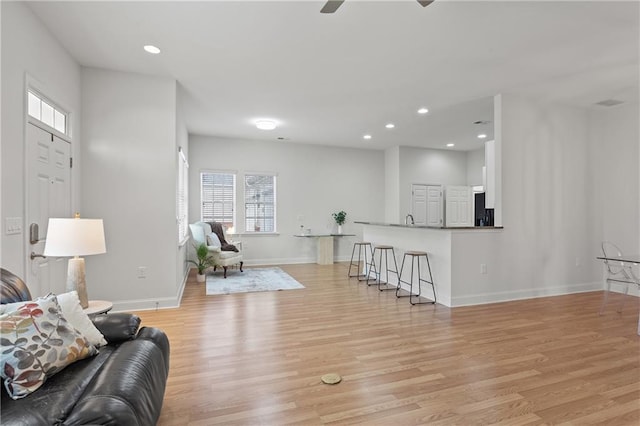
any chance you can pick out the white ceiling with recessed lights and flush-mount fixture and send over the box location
[29,0,640,150]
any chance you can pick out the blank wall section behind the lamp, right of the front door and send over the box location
[81,68,179,310]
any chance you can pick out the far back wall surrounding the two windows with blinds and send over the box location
[189,135,385,265]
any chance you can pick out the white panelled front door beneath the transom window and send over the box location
[25,123,71,298]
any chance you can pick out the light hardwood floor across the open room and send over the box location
[132,263,640,426]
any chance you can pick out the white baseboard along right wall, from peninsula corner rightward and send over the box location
[451,282,602,307]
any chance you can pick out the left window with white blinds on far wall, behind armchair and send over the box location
[200,172,236,228]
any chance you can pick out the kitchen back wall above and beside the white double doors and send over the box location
[400,146,467,222]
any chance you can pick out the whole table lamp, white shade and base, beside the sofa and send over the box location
[44,218,107,308]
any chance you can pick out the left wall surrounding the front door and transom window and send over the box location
[0,2,81,277]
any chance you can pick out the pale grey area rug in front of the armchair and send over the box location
[207,268,304,296]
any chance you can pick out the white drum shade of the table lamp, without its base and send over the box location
[44,218,107,257]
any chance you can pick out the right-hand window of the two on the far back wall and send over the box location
[244,174,276,232]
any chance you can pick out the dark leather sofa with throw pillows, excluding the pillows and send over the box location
[0,269,169,425]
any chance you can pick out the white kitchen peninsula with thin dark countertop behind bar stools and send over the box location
[354,221,504,307]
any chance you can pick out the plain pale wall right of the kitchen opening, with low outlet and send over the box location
[453,95,600,305]
